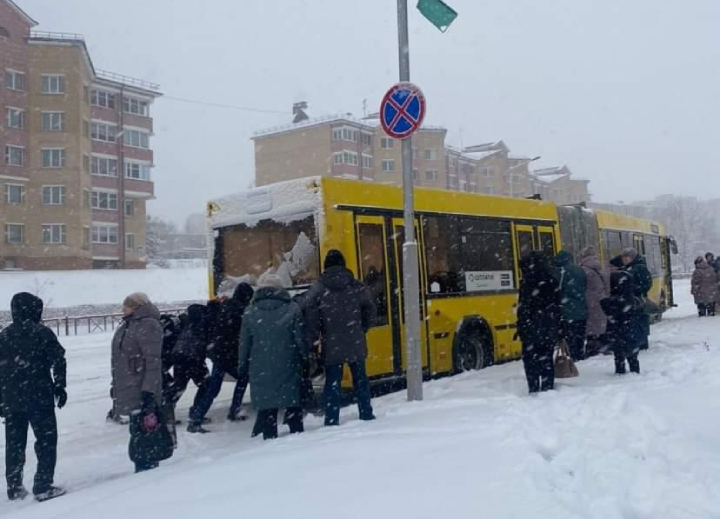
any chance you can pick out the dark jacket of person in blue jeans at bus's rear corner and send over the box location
[305,265,375,365]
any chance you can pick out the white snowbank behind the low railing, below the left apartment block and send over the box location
[0,267,208,311]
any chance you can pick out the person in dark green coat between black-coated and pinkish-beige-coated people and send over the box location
[555,251,588,362]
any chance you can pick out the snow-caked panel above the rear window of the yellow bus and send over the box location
[209,177,322,229]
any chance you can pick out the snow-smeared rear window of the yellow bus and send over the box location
[215,216,320,295]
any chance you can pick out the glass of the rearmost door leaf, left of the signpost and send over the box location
[358,224,388,326]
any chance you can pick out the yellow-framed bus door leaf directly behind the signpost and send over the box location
[392,218,428,371]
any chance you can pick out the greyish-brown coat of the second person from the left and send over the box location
[111,303,163,415]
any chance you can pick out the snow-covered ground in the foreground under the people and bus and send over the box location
[0,282,720,519]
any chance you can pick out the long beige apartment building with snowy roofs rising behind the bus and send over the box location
[253,115,588,203]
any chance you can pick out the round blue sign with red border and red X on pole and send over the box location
[380,82,425,139]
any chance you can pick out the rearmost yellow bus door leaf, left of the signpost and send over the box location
[356,216,396,377]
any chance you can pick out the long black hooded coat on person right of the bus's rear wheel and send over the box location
[518,251,562,351]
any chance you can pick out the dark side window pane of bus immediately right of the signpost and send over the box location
[423,216,464,294]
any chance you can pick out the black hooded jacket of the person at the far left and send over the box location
[0,292,66,413]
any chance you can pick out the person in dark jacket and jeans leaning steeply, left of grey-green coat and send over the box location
[196,283,254,422]
